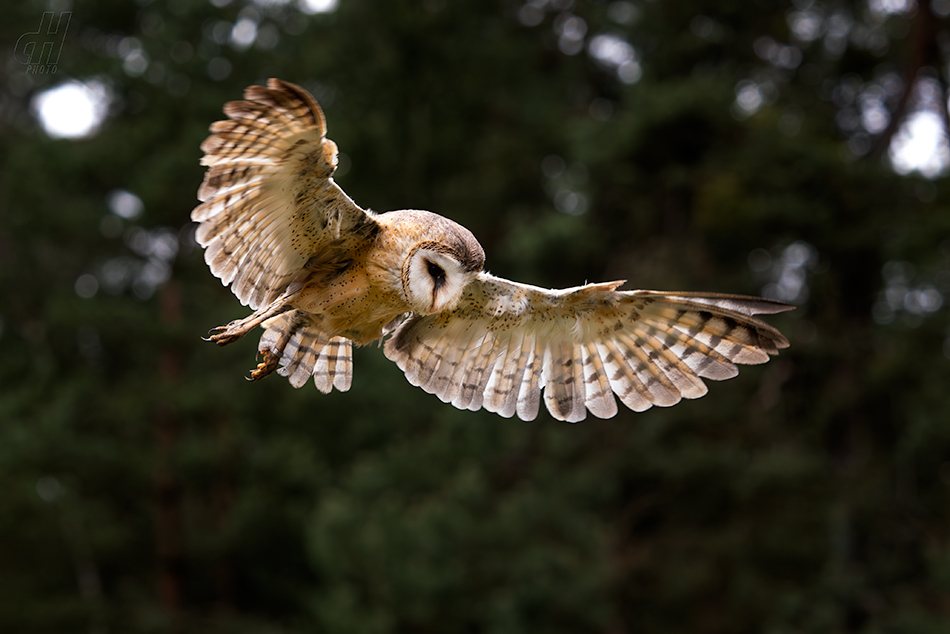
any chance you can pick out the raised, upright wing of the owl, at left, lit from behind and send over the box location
[191,79,375,309]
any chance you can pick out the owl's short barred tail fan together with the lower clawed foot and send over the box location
[251,309,353,394]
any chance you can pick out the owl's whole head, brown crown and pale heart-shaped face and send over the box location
[402,212,485,315]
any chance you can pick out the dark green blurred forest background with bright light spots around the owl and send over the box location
[0,0,950,634]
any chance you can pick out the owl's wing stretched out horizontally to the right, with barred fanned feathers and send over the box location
[385,273,794,422]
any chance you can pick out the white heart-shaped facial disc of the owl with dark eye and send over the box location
[402,242,478,315]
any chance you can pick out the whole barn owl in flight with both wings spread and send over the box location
[191,79,792,422]
